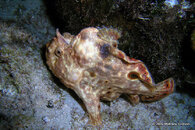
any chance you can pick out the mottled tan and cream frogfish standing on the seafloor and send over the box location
[46,27,174,125]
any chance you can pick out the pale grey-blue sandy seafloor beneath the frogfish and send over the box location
[0,0,195,130]
